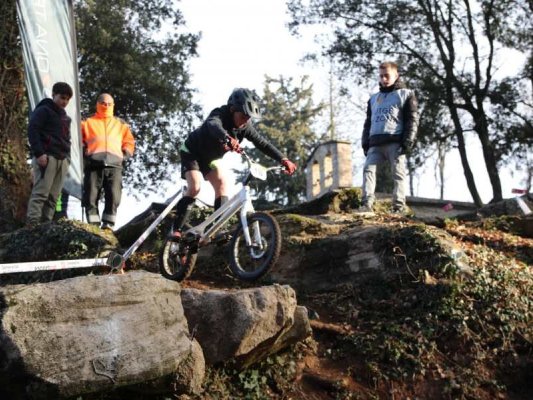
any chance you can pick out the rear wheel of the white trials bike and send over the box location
[159,239,198,282]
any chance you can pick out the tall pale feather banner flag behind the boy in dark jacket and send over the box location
[17,0,83,199]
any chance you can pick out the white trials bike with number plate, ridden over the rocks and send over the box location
[159,150,283,281]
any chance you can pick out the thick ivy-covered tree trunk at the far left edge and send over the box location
[0,0,31,233]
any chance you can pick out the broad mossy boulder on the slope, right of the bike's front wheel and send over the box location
[269,222,470,292]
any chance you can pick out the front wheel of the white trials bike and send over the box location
[229,212,281,281]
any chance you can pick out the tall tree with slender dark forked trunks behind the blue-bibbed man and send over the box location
[288,0,531,205]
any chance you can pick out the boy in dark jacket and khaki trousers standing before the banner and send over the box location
[26,82,72,226]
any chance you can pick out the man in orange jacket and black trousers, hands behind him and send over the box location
[81,93,135,230]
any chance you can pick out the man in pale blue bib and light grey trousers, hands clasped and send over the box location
[360,62,418,214]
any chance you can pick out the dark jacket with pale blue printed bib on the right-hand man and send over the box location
[361,79,418,149]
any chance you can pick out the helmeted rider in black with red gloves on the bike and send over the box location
[172,88,296,239]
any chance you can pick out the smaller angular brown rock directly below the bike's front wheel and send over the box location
[181,285,311,365]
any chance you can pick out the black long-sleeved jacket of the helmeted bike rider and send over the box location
[181,106,284,163]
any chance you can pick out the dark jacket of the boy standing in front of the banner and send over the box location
[28,99,71,160]
